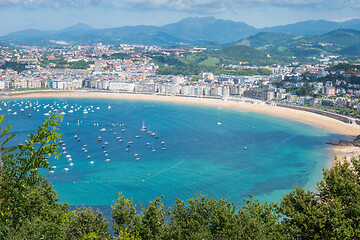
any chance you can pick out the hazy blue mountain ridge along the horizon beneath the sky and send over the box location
[0,17,360,46]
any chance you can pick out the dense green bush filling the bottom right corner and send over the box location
[281,159,360,239]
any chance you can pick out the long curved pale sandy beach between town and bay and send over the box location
[1,91,360,164]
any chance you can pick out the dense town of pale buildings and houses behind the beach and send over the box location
[0,44,360,108]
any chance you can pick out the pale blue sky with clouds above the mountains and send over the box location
[0,0,360,35]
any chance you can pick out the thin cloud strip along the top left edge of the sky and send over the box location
[0,0,108,9]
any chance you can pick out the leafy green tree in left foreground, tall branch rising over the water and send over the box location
[0,113,110,239]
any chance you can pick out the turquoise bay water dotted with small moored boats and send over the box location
[0,98,342,206]
